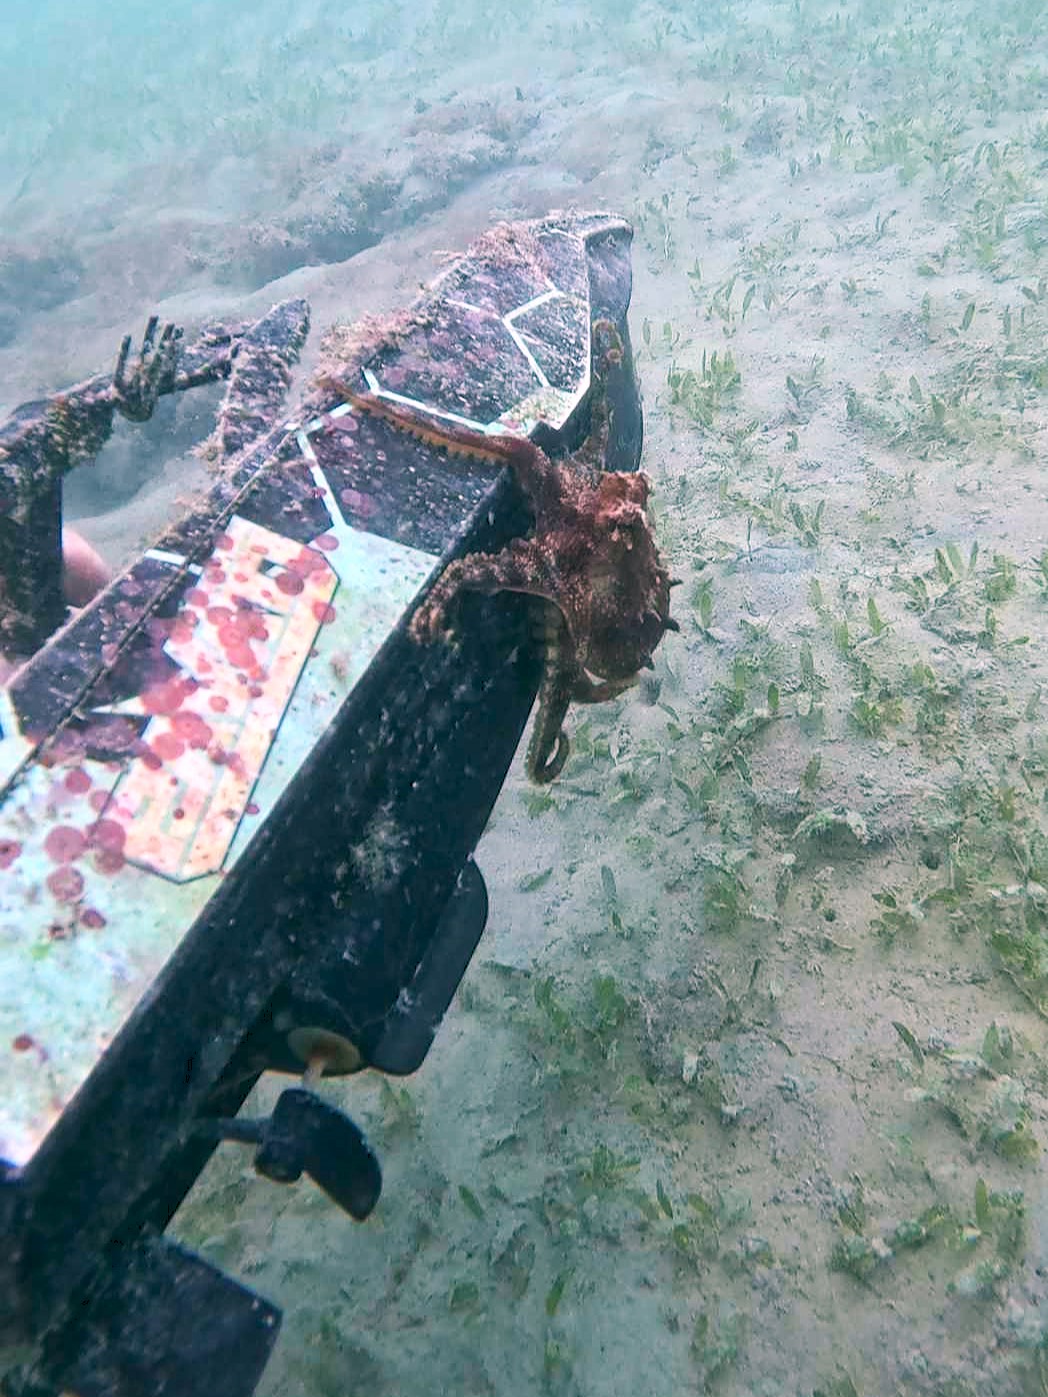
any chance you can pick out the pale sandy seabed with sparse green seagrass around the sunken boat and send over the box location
[0,0,1048,1397]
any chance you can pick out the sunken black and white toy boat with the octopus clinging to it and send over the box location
[0,215,672,1397]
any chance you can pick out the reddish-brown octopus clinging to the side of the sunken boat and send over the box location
[347,377,679,782]
